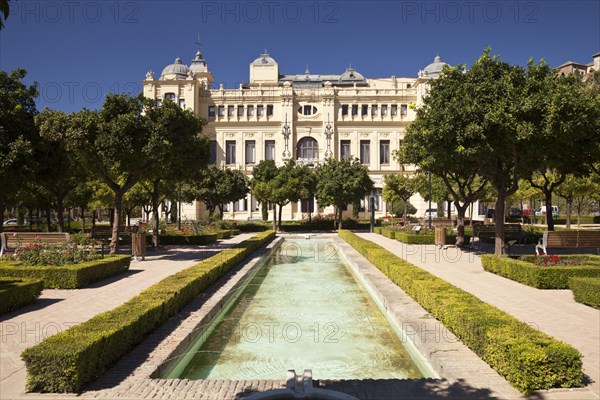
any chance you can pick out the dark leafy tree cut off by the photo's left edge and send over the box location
[0,69,38,231]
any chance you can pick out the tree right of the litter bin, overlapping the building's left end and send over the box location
[145,99,210,247]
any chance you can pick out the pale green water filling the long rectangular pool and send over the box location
[167,239,423,380]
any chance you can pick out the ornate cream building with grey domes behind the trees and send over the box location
[143,51,445,220]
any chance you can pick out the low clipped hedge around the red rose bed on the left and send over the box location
[0,255,131,289]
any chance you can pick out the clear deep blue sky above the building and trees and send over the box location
[0,0,600,111]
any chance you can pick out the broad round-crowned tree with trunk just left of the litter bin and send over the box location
[69,94,156,254]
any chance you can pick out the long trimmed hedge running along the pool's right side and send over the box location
[339,231,583,394]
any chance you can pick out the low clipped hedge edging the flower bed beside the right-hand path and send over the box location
[481,254,600,289]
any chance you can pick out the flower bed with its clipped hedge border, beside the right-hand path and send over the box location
[481,254,600,289]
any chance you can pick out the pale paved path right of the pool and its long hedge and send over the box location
[358,233,600,399]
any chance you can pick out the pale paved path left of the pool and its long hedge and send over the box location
[0,233,254,400]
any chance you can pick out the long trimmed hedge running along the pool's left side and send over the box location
[21,231,275,393]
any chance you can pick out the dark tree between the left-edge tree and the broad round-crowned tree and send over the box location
[35,109,86,232]
